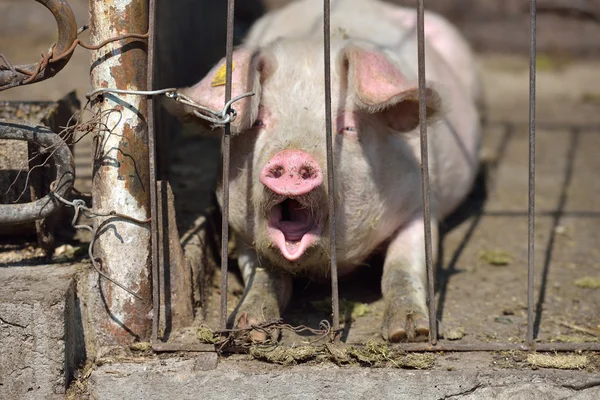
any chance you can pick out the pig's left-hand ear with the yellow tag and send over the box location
[170,48,274,133]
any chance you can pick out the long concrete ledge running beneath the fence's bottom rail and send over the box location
[88,356,600,400]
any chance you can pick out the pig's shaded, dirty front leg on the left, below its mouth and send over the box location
[230,246,292,342]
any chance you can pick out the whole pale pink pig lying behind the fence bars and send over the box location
[171,0,482,342]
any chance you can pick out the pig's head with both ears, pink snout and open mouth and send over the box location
[182,41,441,276]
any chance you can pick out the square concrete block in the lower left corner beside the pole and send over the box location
[0,266,85,399]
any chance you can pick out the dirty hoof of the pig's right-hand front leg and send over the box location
[381,309,429,342]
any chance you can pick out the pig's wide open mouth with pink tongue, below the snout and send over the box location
[267,198,321,261]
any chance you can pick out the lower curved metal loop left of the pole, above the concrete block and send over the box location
[0,119,75,224]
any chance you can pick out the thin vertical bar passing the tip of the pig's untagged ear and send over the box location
[417,0,437,344]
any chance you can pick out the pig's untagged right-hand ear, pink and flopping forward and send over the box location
[344,45,441,132]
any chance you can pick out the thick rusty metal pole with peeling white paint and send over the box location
[89,0,152,344]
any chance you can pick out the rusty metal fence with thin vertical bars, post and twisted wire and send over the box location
[0,0,600,351]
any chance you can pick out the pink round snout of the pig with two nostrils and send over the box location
[260,150,323,196]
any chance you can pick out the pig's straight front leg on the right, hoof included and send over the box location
[381,216,438,342]
